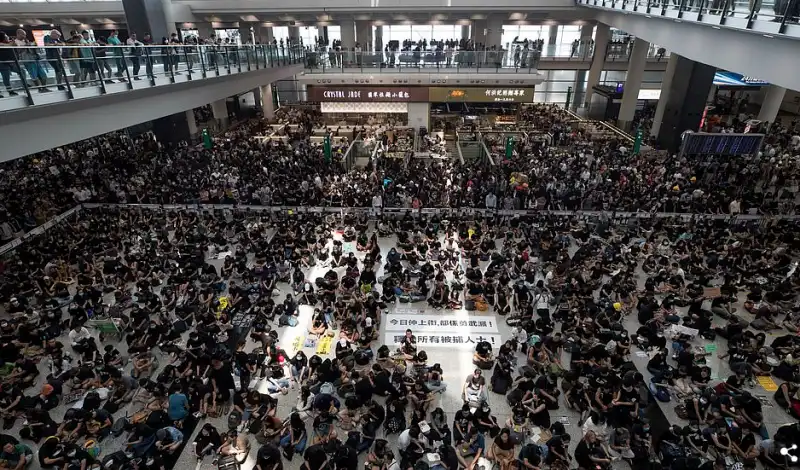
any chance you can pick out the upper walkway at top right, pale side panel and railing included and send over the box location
[576,0,800,90]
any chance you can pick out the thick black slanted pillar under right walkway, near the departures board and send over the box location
[656,52,717,153]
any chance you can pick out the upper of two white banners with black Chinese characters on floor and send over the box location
[385,314,497,335]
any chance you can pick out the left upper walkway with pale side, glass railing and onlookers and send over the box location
[0,47,303,161]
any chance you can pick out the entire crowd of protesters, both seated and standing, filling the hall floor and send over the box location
[0,107,800,470]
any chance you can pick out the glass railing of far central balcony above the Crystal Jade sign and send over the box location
[306,43,668,73]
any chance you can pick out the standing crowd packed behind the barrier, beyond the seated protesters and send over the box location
[0,105,800,242]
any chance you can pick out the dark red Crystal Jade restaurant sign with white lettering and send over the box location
[307,86,428,103]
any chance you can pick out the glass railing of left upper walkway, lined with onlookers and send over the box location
[0,45,305,111]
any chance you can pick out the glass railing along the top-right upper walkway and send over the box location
[576,0,800,36]
